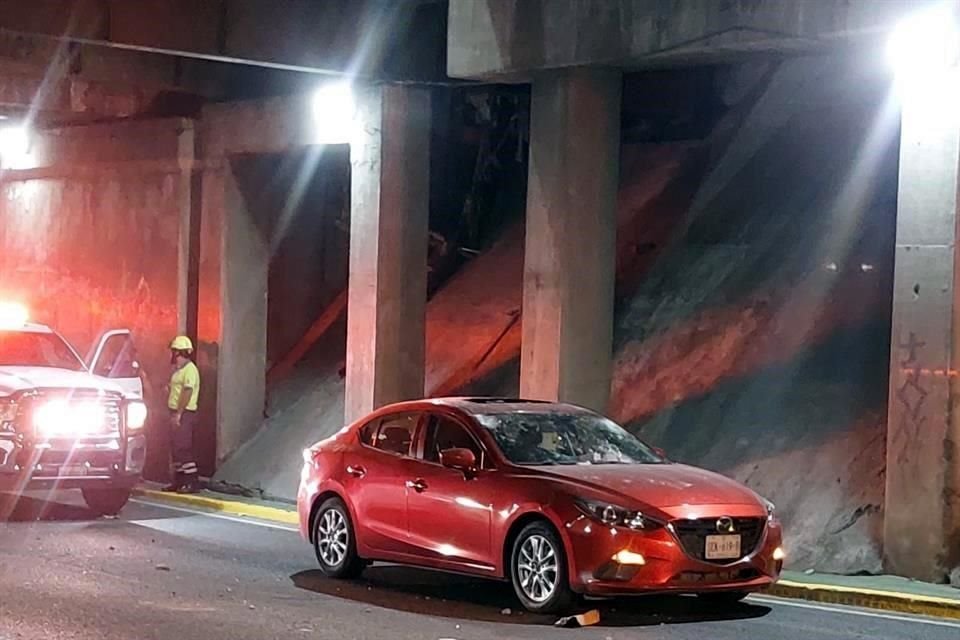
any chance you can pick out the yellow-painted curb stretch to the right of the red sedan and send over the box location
[763,580,960,620]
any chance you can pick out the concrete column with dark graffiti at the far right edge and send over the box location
[884,70,960,581]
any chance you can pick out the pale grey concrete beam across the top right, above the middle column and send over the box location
[447,0,936,80]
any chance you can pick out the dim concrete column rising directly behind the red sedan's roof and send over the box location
[520,69,621,411]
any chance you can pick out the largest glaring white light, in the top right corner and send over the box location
[887,4,960,86]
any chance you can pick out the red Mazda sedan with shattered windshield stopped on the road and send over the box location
[298,398,783,613]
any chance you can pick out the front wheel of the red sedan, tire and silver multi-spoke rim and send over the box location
[510,522,575,614]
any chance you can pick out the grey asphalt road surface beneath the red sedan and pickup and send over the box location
[0,494,960,640]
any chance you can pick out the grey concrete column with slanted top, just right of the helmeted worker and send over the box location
[217,161,270,464]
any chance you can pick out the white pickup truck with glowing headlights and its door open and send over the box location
[0,305,147,515]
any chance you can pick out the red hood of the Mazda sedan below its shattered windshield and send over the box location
[538,464,765,511]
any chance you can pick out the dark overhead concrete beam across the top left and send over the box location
[0,0,443,80]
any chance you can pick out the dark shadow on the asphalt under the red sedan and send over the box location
[291,565,770,627]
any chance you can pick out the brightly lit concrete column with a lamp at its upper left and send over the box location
[344,86,430,422]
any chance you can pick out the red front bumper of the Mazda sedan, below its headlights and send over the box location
[565,510,783,597]
